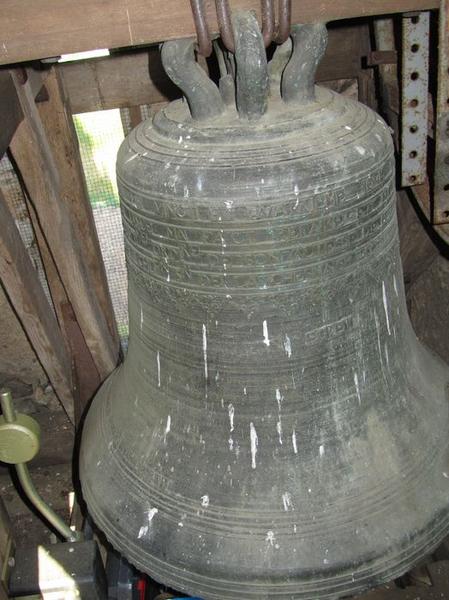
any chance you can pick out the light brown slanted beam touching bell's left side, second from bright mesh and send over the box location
[10,69,119,380]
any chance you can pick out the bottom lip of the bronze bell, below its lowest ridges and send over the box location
[82,468,449,600]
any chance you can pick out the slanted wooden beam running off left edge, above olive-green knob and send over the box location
[0,191,74,422]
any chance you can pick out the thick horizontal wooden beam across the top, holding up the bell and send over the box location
[0,0,439,64]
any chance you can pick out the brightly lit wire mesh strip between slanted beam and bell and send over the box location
[73,109,128,349]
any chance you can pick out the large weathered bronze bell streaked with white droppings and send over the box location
[80,13,449,600]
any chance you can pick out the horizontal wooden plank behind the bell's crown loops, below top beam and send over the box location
[58,24,369,113]
